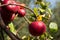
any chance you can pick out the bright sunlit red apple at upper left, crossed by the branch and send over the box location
[2,0,18,12]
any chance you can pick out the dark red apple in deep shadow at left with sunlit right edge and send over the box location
[1,9,15,25]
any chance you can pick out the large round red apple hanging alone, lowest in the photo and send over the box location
[29,21,46,36]
